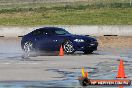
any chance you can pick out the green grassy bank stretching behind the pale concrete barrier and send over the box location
[0,0,132,26]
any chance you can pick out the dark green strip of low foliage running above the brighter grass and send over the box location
[0,3,132,13]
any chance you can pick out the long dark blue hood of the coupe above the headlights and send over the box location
[62,34,97,41]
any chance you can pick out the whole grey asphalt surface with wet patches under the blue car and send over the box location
[0,38,132,88]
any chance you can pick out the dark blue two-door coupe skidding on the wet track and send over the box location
[21,27,98,54]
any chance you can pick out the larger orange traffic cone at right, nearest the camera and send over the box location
[116,60,127,78]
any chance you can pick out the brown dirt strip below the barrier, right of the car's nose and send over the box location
[97,36,132,48]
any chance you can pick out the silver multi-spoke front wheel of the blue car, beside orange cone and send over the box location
[63,40,75,54]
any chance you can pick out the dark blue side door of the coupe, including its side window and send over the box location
[34,28,63,51]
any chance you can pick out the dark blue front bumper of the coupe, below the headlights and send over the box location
[74,41,98,51]
